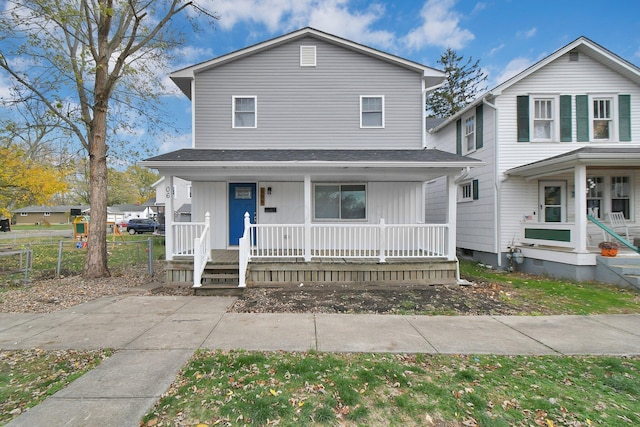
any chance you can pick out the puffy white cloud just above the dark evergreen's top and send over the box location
[404,0,475,50]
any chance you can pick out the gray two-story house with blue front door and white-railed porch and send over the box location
[142,28,480,286]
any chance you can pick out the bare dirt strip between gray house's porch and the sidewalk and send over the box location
[231,283,546,315]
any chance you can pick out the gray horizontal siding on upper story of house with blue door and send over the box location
[194,38,424,149]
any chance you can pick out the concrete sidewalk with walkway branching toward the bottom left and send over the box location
[0,296,640,427]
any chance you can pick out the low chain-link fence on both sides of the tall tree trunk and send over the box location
[0,238,164,283]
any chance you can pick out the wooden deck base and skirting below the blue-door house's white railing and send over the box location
[166,250,456,286]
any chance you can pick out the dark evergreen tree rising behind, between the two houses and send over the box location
[426,48,487,118]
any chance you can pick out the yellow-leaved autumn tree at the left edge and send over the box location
[0,142,66,218]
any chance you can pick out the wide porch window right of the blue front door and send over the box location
[313,184,367,220]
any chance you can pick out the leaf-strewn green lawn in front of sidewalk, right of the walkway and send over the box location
[143,351,640,427]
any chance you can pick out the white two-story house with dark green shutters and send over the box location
[426,37,640,286]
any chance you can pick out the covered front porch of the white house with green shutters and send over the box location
[505,146,640,288]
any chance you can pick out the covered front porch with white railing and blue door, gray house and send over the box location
[144,149,480,287]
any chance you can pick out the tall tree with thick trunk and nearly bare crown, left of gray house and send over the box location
[0,0,215,278]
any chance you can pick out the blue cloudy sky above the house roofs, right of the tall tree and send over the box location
[158,0,640,152]
